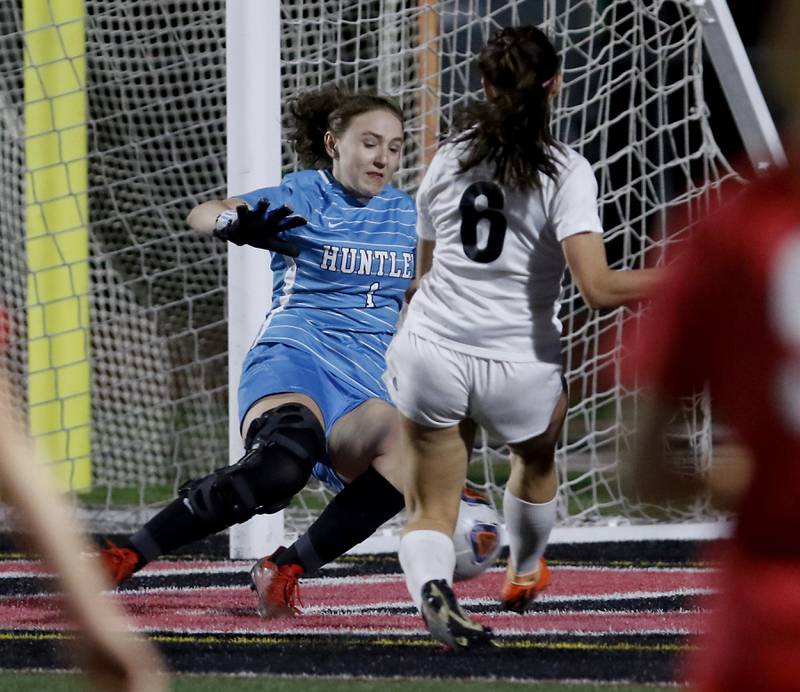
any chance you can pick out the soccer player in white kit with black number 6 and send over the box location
[385,26,661,648]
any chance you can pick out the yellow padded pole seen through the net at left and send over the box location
[23,0,91,490]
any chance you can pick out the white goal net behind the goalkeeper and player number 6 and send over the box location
[0,0,752,548]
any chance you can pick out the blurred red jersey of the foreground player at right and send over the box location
[639,172,800,557]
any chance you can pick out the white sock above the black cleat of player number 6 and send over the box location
[398,530,456,610]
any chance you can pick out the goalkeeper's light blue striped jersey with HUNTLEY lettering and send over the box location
[236,170,416,397]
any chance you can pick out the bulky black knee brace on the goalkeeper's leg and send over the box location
[179,404,325,526]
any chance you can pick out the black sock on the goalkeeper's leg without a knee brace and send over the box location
[275,466,405,572]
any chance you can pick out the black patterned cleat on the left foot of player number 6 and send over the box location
[421,579,495,649]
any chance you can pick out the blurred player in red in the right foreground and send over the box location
[632,0,800,692]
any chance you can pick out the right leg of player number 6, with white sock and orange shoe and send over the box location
[500,393,567,612]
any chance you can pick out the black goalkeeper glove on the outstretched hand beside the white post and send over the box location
[214,199,308,257]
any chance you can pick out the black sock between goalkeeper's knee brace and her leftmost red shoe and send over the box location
[128,497,228,567]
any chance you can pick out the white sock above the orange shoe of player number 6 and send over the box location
[503,488,558,574]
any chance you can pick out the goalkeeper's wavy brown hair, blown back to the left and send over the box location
[288,84,403,168]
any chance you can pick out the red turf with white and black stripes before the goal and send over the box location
[0,561,711,637]
